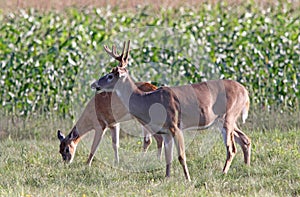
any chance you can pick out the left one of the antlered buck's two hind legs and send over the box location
[222,127,236,174]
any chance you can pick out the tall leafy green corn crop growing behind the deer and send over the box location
[0,2,300,117]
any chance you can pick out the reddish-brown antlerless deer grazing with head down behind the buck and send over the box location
[57,83,162,165]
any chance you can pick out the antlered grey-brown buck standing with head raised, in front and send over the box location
[91,41,251,181]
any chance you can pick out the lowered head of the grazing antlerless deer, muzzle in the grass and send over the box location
[57,128,79,163]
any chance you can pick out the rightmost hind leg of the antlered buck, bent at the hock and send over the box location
[234,125,251,165]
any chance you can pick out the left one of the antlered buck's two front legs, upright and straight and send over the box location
[163,134,173,177]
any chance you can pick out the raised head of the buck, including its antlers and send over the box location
[91,40,130,91]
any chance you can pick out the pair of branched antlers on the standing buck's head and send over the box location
[104,40,130,67]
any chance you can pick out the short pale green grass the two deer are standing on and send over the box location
[0,117,300,196]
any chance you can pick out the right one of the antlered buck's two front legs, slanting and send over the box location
[174,129,191,181]
